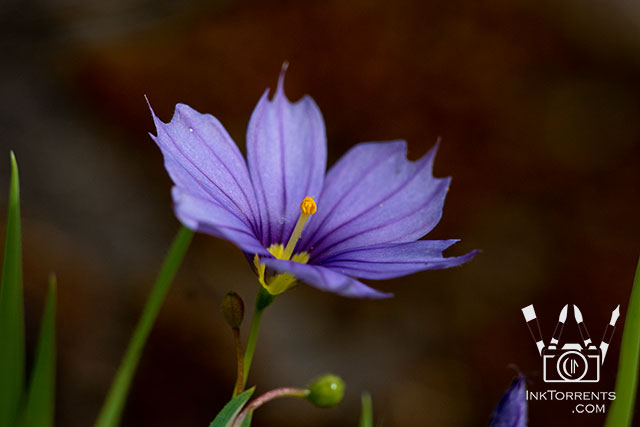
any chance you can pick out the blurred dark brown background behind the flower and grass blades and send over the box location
[0,0,640,427]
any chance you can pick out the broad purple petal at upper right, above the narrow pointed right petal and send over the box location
[299,141,450,263]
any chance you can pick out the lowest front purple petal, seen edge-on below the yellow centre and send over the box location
[260,258,393,298]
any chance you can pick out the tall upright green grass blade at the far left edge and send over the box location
[0,152,24,426]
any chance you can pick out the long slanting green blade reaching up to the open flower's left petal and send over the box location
[95,226,193,427]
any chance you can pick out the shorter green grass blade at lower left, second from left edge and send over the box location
[22,275,56,427]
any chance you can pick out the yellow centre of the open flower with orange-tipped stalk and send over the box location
[253,197,318,295]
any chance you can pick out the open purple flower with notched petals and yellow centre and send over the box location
[146,68,476,298]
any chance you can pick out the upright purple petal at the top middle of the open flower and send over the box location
[247,68,327,246]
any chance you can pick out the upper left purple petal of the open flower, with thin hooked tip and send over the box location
[149,104,260,234]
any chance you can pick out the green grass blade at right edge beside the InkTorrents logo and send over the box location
[605,260,640,427]
